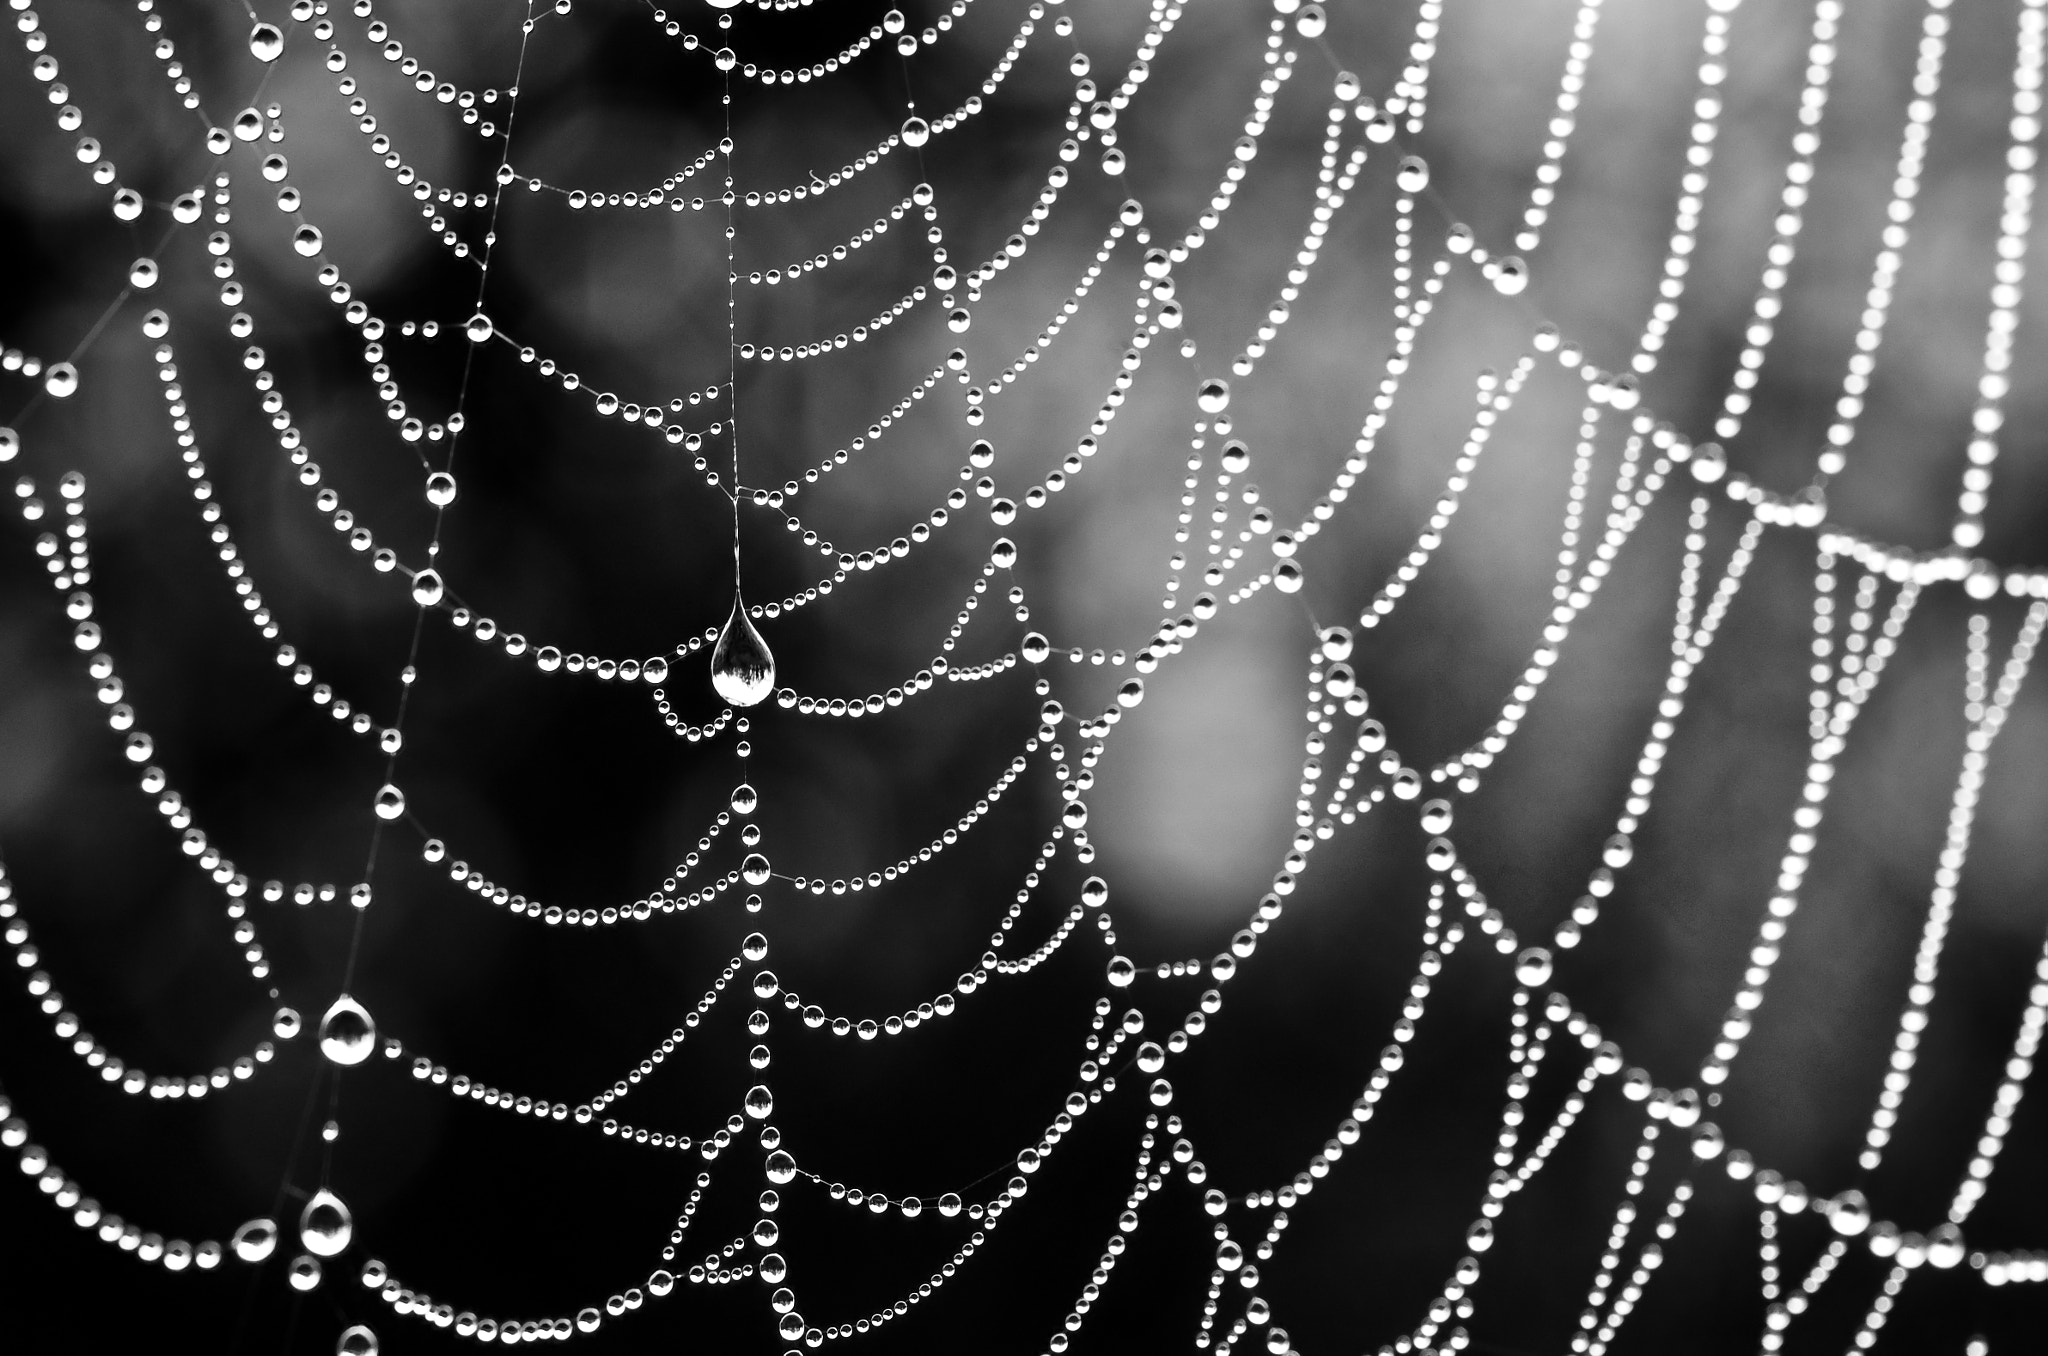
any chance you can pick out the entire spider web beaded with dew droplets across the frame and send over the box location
[0,0,2048,1354]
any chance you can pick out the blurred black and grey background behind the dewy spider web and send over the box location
[0,0,2048,1352]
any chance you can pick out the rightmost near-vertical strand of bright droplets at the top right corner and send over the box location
[1950,0,2048,551]
